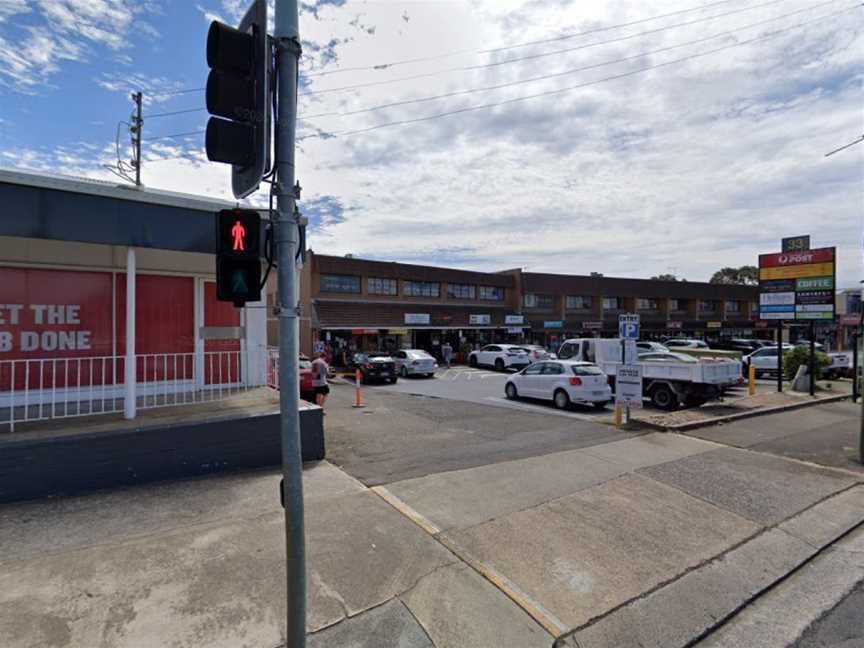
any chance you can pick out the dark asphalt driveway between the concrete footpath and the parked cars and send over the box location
[324,377,634,486]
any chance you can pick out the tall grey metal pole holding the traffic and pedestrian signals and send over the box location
[274,0,306,648]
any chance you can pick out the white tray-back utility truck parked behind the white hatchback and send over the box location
[558,338,744,410]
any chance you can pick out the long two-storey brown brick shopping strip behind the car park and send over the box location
[282,251,756,360]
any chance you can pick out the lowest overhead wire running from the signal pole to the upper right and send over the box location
[298,3,864,141]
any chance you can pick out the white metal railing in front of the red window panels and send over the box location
[0,347,266,431]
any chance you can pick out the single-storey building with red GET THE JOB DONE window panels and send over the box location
[0,169,323,501]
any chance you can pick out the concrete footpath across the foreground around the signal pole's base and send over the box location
[0,420,864,648]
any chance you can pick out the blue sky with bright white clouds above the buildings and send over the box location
[0,0,864,287]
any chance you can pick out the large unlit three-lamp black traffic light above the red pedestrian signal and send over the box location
[205,0,272,198]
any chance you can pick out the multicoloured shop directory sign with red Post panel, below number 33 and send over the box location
[759,247,837,321]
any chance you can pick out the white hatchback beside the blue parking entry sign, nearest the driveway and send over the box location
[504,360,612,409]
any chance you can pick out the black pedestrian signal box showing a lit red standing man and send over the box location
[216,209,261,308]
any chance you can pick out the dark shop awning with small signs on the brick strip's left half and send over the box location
[314,299,512,330]
